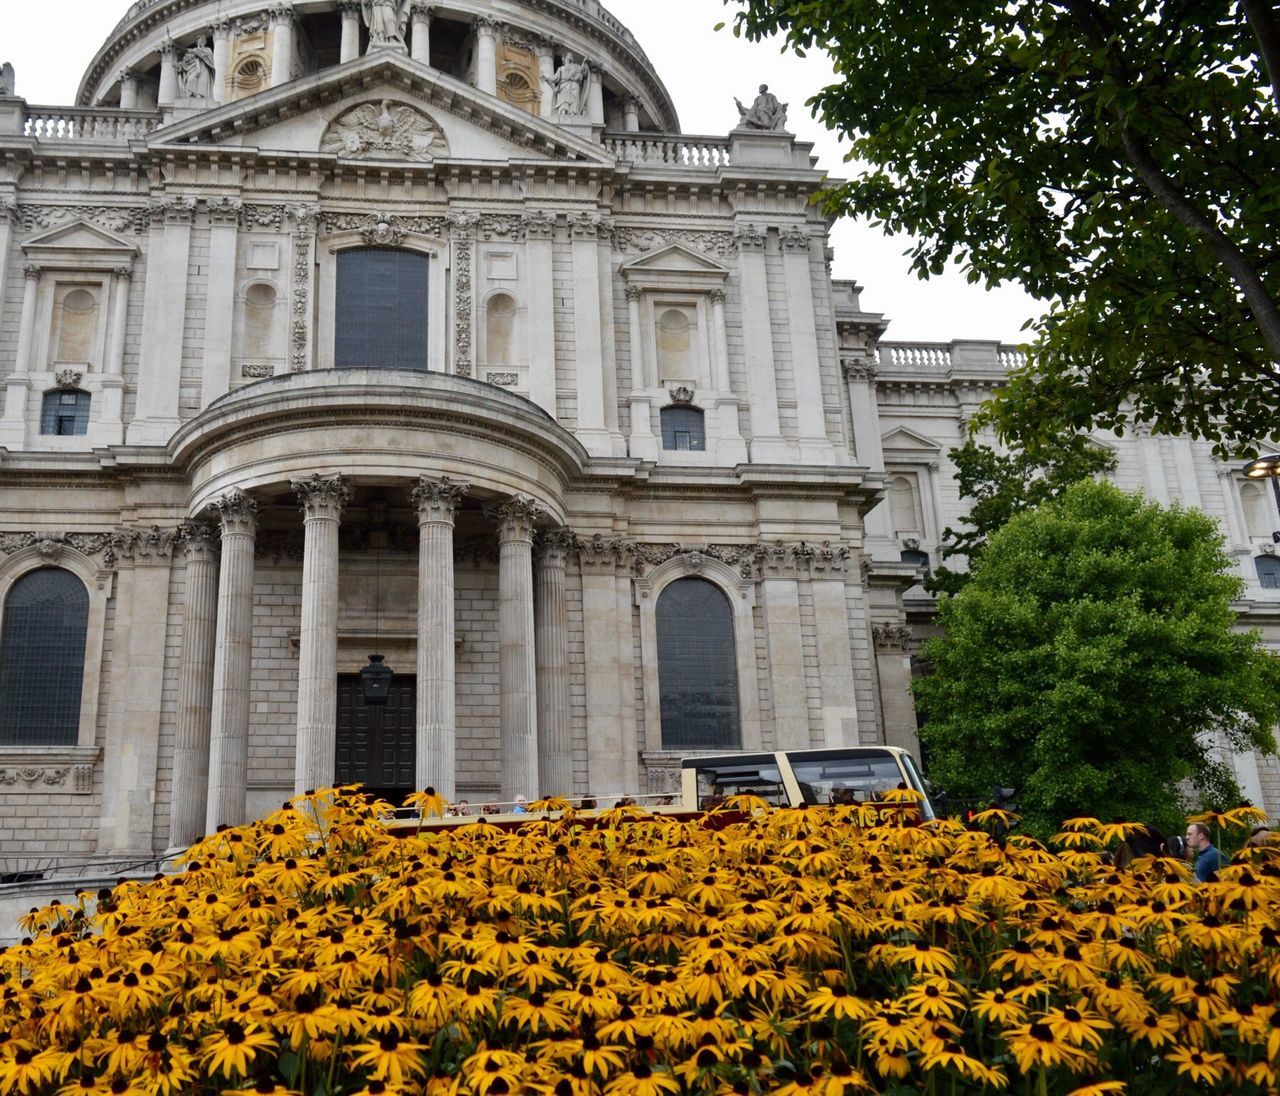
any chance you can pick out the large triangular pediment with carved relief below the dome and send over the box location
[148,52,614,165]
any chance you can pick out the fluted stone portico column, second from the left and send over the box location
[205,490,257,834]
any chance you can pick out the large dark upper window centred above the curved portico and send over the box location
[333,247,430,369]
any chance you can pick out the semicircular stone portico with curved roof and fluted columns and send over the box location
[170,369,586,845]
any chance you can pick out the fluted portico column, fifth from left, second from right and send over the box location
[489,497,540,802]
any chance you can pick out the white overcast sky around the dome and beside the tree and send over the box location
[0,0,1038,342]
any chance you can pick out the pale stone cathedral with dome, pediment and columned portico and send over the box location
[0,0,1280,871]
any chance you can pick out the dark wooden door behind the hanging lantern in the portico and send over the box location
[335,673,417,804]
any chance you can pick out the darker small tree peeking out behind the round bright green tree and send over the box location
[925,434,1116,594]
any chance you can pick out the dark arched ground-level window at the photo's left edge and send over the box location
[0,567,88,746]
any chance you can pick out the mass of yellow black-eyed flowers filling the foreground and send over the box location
[0,791,1280,1096]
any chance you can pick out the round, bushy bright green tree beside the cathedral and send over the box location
[915,480,1280,832]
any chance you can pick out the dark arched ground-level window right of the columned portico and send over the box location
[657,579,742,750]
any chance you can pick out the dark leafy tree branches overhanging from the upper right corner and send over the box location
[726,0,1280,452]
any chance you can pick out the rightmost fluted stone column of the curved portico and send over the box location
[534,529,573,796]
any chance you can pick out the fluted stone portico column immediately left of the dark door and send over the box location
[291,472,351,794]
